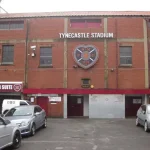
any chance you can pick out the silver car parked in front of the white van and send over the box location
[4,105,47,136]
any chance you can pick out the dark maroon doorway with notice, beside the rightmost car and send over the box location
[125,96,142,117]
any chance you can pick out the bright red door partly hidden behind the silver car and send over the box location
[37,97,48,115]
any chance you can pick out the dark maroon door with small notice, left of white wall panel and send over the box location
[67,96,84,117]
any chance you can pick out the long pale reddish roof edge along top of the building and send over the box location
[0,11,150,19]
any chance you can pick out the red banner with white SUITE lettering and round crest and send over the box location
[0,82,23,92]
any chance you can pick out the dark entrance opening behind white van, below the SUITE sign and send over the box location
[0,95,21,114]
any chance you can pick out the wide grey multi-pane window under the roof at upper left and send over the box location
[0,21,24,30]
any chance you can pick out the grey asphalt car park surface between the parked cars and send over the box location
[4,119,150,150]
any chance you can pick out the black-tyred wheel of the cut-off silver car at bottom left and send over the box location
[12,131,21,149]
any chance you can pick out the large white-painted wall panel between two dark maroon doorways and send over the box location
[89,94,125,118]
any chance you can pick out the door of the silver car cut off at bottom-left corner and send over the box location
[0,118,13,147]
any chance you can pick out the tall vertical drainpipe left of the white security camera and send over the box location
[24,19,29,88]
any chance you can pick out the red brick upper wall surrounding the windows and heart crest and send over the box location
[0,17,145,88]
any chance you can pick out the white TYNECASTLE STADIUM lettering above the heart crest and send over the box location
[59,33,113,39]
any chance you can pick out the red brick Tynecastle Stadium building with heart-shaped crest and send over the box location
[0,12,150,118]
